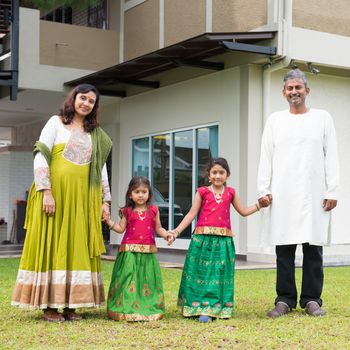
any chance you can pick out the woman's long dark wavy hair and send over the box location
[59,84,100,132]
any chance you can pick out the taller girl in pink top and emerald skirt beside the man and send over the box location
[172,158,260,322]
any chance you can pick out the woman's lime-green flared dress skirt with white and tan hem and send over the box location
[12,144,104,309]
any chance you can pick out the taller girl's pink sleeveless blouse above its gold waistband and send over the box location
[196,186,235,230]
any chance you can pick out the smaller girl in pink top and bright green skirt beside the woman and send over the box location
[105,176,174,321]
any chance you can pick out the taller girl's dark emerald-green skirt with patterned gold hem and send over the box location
[178,234,236,318]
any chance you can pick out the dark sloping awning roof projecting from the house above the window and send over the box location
[66,31,276,97]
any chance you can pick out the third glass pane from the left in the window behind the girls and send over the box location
[173,130,193,238]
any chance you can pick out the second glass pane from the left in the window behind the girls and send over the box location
[152,134,170,230]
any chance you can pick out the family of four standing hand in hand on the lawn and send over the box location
[12,69,339,323]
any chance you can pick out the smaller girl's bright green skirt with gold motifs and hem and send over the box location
[107,252,164,321]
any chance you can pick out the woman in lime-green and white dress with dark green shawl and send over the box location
[12,84,112,322]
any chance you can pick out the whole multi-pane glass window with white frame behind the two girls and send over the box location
[132,125,218,238]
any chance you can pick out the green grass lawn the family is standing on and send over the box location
[0,259,350,350]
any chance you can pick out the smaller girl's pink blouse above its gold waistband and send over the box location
[121,205,158,246]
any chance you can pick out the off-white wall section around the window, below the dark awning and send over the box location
[117,68,245,248]
